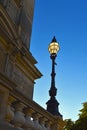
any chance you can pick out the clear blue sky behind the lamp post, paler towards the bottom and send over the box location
[30,0,87,120]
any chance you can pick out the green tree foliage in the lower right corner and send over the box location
[64,102,87,130]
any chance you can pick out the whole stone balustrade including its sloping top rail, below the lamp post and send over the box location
[2,92,64,130]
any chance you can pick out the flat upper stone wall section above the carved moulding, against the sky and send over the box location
[0,0,34,49]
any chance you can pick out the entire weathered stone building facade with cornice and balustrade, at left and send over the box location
[0,0,64,130]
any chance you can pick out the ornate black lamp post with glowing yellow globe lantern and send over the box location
[46,37,62,116]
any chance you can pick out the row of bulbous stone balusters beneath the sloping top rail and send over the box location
[5,96,51,130]
